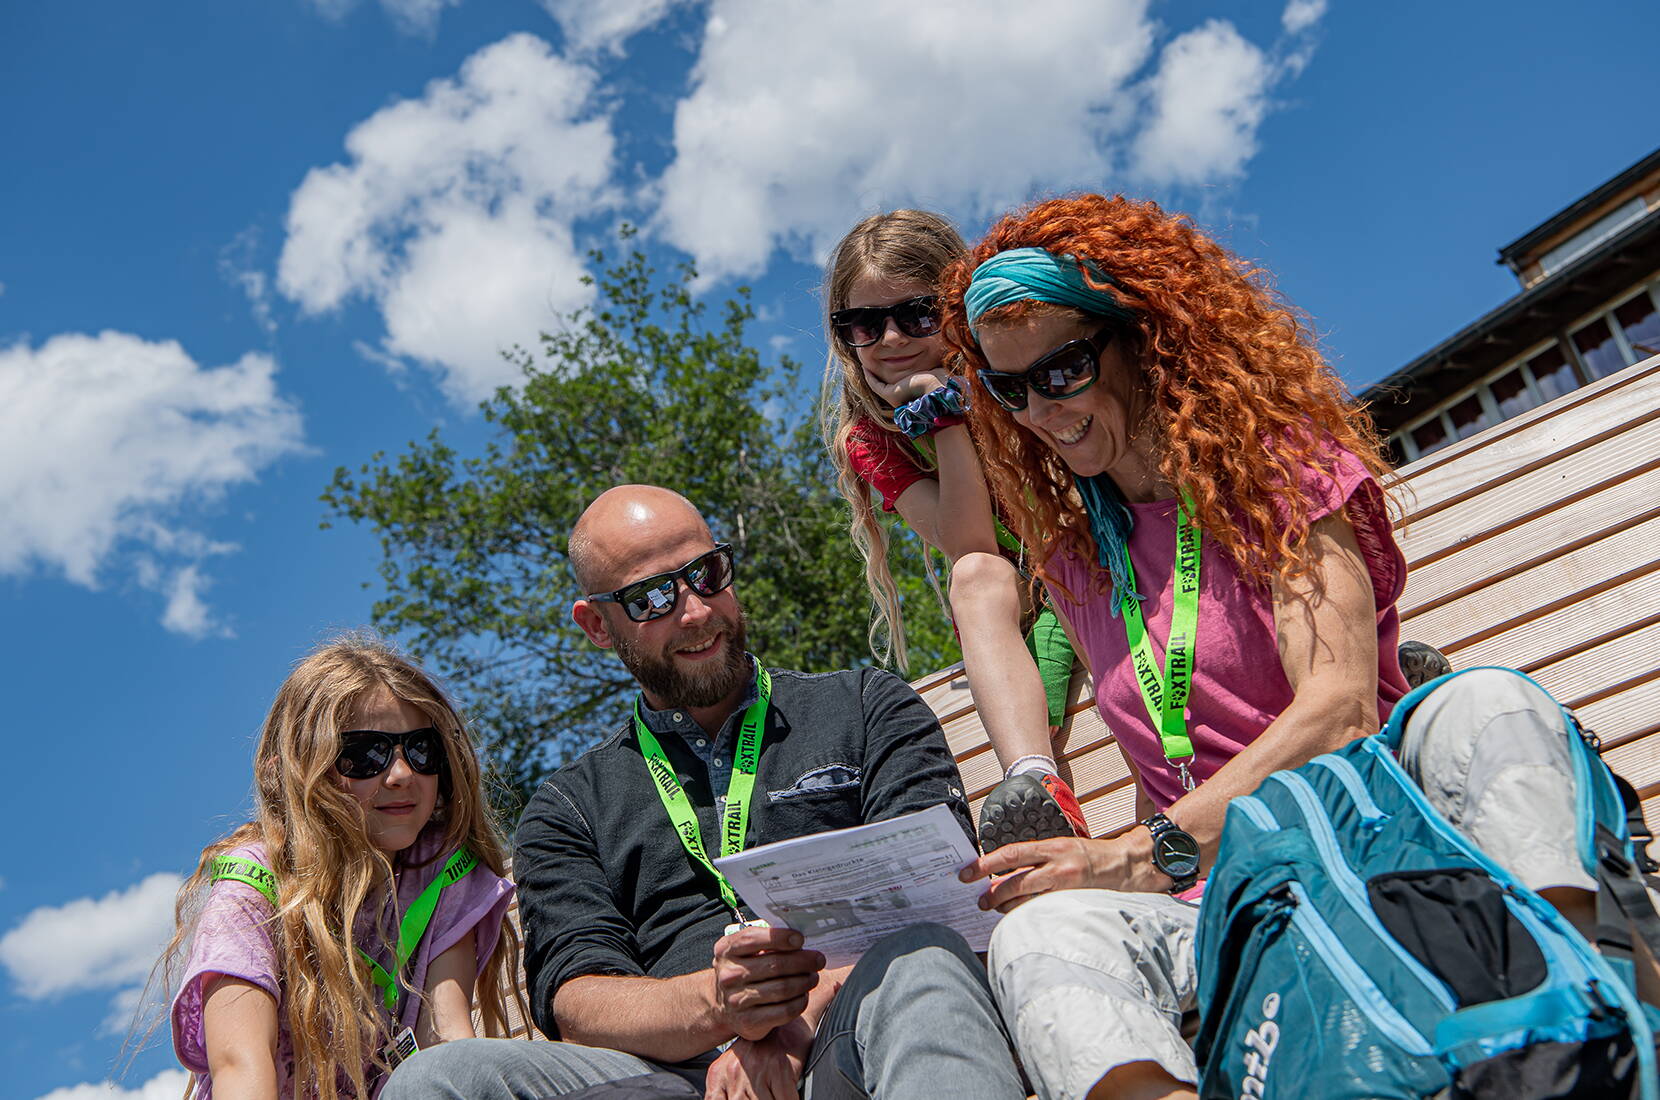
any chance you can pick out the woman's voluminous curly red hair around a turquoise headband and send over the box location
[941,194,1389,584]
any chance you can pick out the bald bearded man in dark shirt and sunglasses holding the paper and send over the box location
[395,484,1026,1100]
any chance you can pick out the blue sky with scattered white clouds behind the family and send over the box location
[0,0,1660,1100]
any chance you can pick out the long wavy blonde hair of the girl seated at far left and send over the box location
[159,634,525,1100]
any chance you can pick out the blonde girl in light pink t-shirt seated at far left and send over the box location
[163,637,518,1100]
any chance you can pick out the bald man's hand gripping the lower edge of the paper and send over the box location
[714,927,825,1042]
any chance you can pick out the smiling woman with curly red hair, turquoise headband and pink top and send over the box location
[945,196,1408,1097]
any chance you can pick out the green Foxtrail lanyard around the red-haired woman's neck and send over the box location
[1121,496,1199,791]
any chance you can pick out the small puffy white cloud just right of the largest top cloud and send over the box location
[1132,20,1275,186]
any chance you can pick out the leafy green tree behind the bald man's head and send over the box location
[322,232,956,809]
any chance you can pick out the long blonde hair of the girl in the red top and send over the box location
[818,211,968,672]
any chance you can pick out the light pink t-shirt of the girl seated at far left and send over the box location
[173,823,513,1100]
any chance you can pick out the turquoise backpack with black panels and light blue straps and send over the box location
[1195,674,1660,1100]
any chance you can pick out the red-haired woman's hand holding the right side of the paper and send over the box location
[958,828,1170,913]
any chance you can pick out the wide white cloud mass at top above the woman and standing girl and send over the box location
[652,0,1314,277]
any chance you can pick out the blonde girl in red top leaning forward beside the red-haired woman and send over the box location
[823,211,1087,851]
